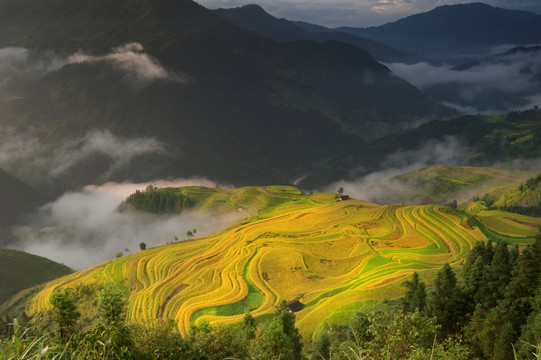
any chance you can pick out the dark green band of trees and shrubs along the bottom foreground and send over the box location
[0,229,541,360]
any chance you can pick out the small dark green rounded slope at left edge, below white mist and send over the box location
[0,248,72,304]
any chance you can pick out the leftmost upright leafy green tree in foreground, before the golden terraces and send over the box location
[49,290,81,341]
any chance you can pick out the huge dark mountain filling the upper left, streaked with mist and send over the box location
[0,0,441,193]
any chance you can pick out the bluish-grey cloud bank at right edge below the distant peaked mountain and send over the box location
[387,46,541,113]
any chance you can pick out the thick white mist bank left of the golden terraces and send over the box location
[15,179,240,270]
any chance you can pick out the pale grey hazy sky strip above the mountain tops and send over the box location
[196,0,541,27]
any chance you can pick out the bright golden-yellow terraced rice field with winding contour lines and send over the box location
[31,187,539,337]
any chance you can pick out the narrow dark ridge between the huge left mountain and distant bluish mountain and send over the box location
[214,5,423,64]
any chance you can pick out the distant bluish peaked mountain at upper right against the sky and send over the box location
[336,3,541,63]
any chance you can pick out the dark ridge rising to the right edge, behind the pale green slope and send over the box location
[298,109,541,189]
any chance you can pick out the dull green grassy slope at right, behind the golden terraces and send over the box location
[395,165,528,202]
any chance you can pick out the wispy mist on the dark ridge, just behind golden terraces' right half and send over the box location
[323,137,471,204]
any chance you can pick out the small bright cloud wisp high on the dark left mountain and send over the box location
[67,42,188,83]
